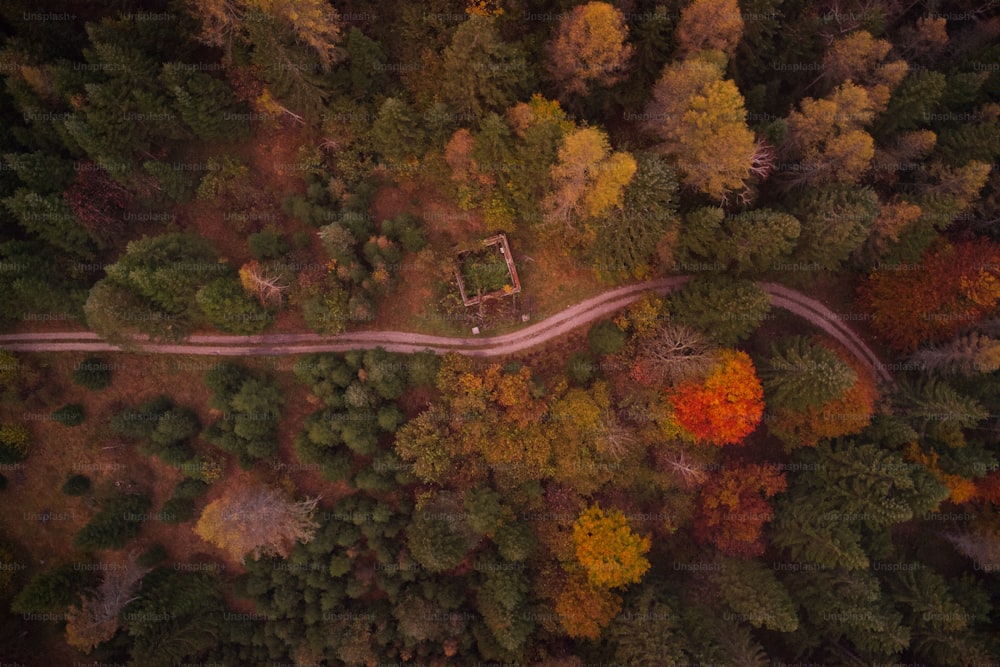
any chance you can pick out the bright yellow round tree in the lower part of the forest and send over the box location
[573,505,650,588]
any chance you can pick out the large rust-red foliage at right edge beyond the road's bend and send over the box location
[859,241,1000,352]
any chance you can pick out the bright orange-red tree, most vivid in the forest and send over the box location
[669,350,764,446]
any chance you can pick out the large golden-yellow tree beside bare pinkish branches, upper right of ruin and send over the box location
[646,51,757,201]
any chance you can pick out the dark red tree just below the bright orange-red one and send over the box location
[694,464,788,558]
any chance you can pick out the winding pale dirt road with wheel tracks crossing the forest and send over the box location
[0,276,893,384]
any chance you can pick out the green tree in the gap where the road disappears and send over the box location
[669,275,771,347]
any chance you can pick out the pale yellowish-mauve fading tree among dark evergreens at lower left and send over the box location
[194,486,319,561]
